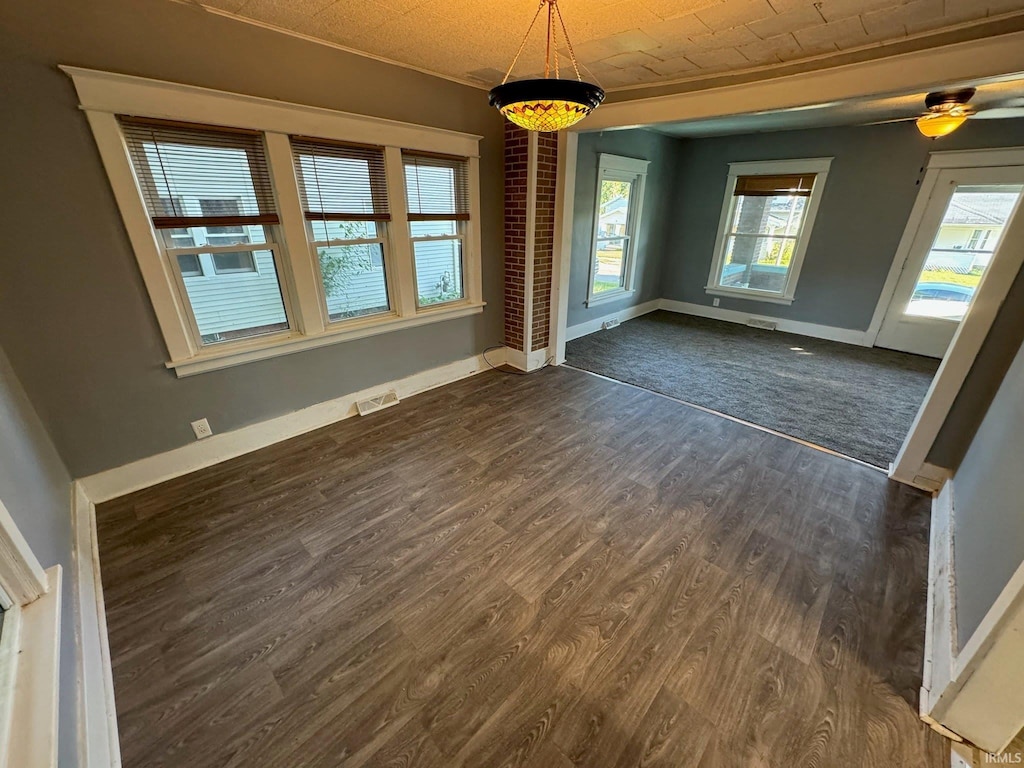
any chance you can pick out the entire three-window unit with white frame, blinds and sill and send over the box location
[75,68,484,376]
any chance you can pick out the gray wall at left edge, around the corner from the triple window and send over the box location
[0,348,78,768]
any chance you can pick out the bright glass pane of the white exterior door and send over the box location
[906,184,1024,321]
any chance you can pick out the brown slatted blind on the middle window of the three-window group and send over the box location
[292,136,391,221]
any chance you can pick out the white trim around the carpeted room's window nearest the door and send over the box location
[705,158,833,304]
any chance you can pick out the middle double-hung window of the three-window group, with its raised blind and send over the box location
[292,137,391,323]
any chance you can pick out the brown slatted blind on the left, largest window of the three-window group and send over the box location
[119,116,278,229]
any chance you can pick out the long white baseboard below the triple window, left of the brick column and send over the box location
[78,350,495,504]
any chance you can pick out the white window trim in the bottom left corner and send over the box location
[0,502,62,768]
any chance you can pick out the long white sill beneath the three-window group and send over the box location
[166,301,486,378]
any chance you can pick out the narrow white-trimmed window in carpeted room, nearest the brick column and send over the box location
[587,155,648,304]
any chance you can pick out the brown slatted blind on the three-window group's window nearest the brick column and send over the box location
[401,152,469,221]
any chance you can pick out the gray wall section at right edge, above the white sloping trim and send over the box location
[953,337,1024,648]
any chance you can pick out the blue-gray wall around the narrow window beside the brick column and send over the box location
[568,130,681,327]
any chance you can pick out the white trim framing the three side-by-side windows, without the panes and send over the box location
[60,67,484,376]
